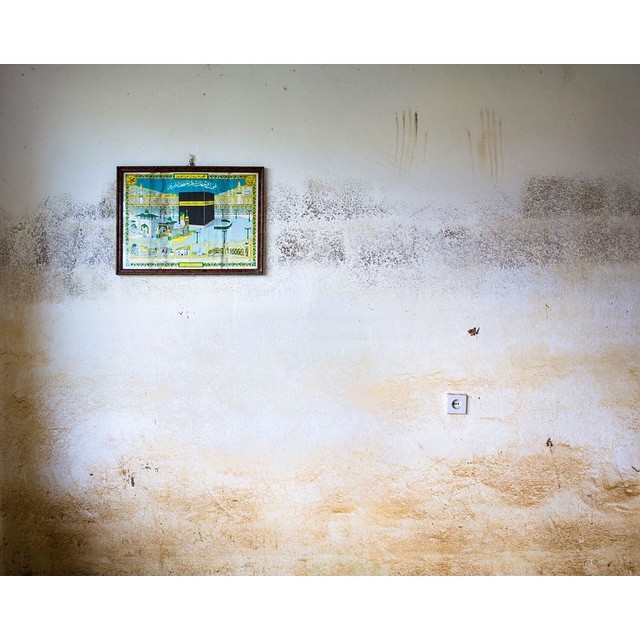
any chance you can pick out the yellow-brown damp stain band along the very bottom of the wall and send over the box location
[3,445,640,575]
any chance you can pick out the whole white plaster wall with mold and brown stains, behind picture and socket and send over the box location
[0,65,640,574]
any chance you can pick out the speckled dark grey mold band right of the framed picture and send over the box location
[272,178,640,278]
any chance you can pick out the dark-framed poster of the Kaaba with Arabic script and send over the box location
[116,166,264,275]
